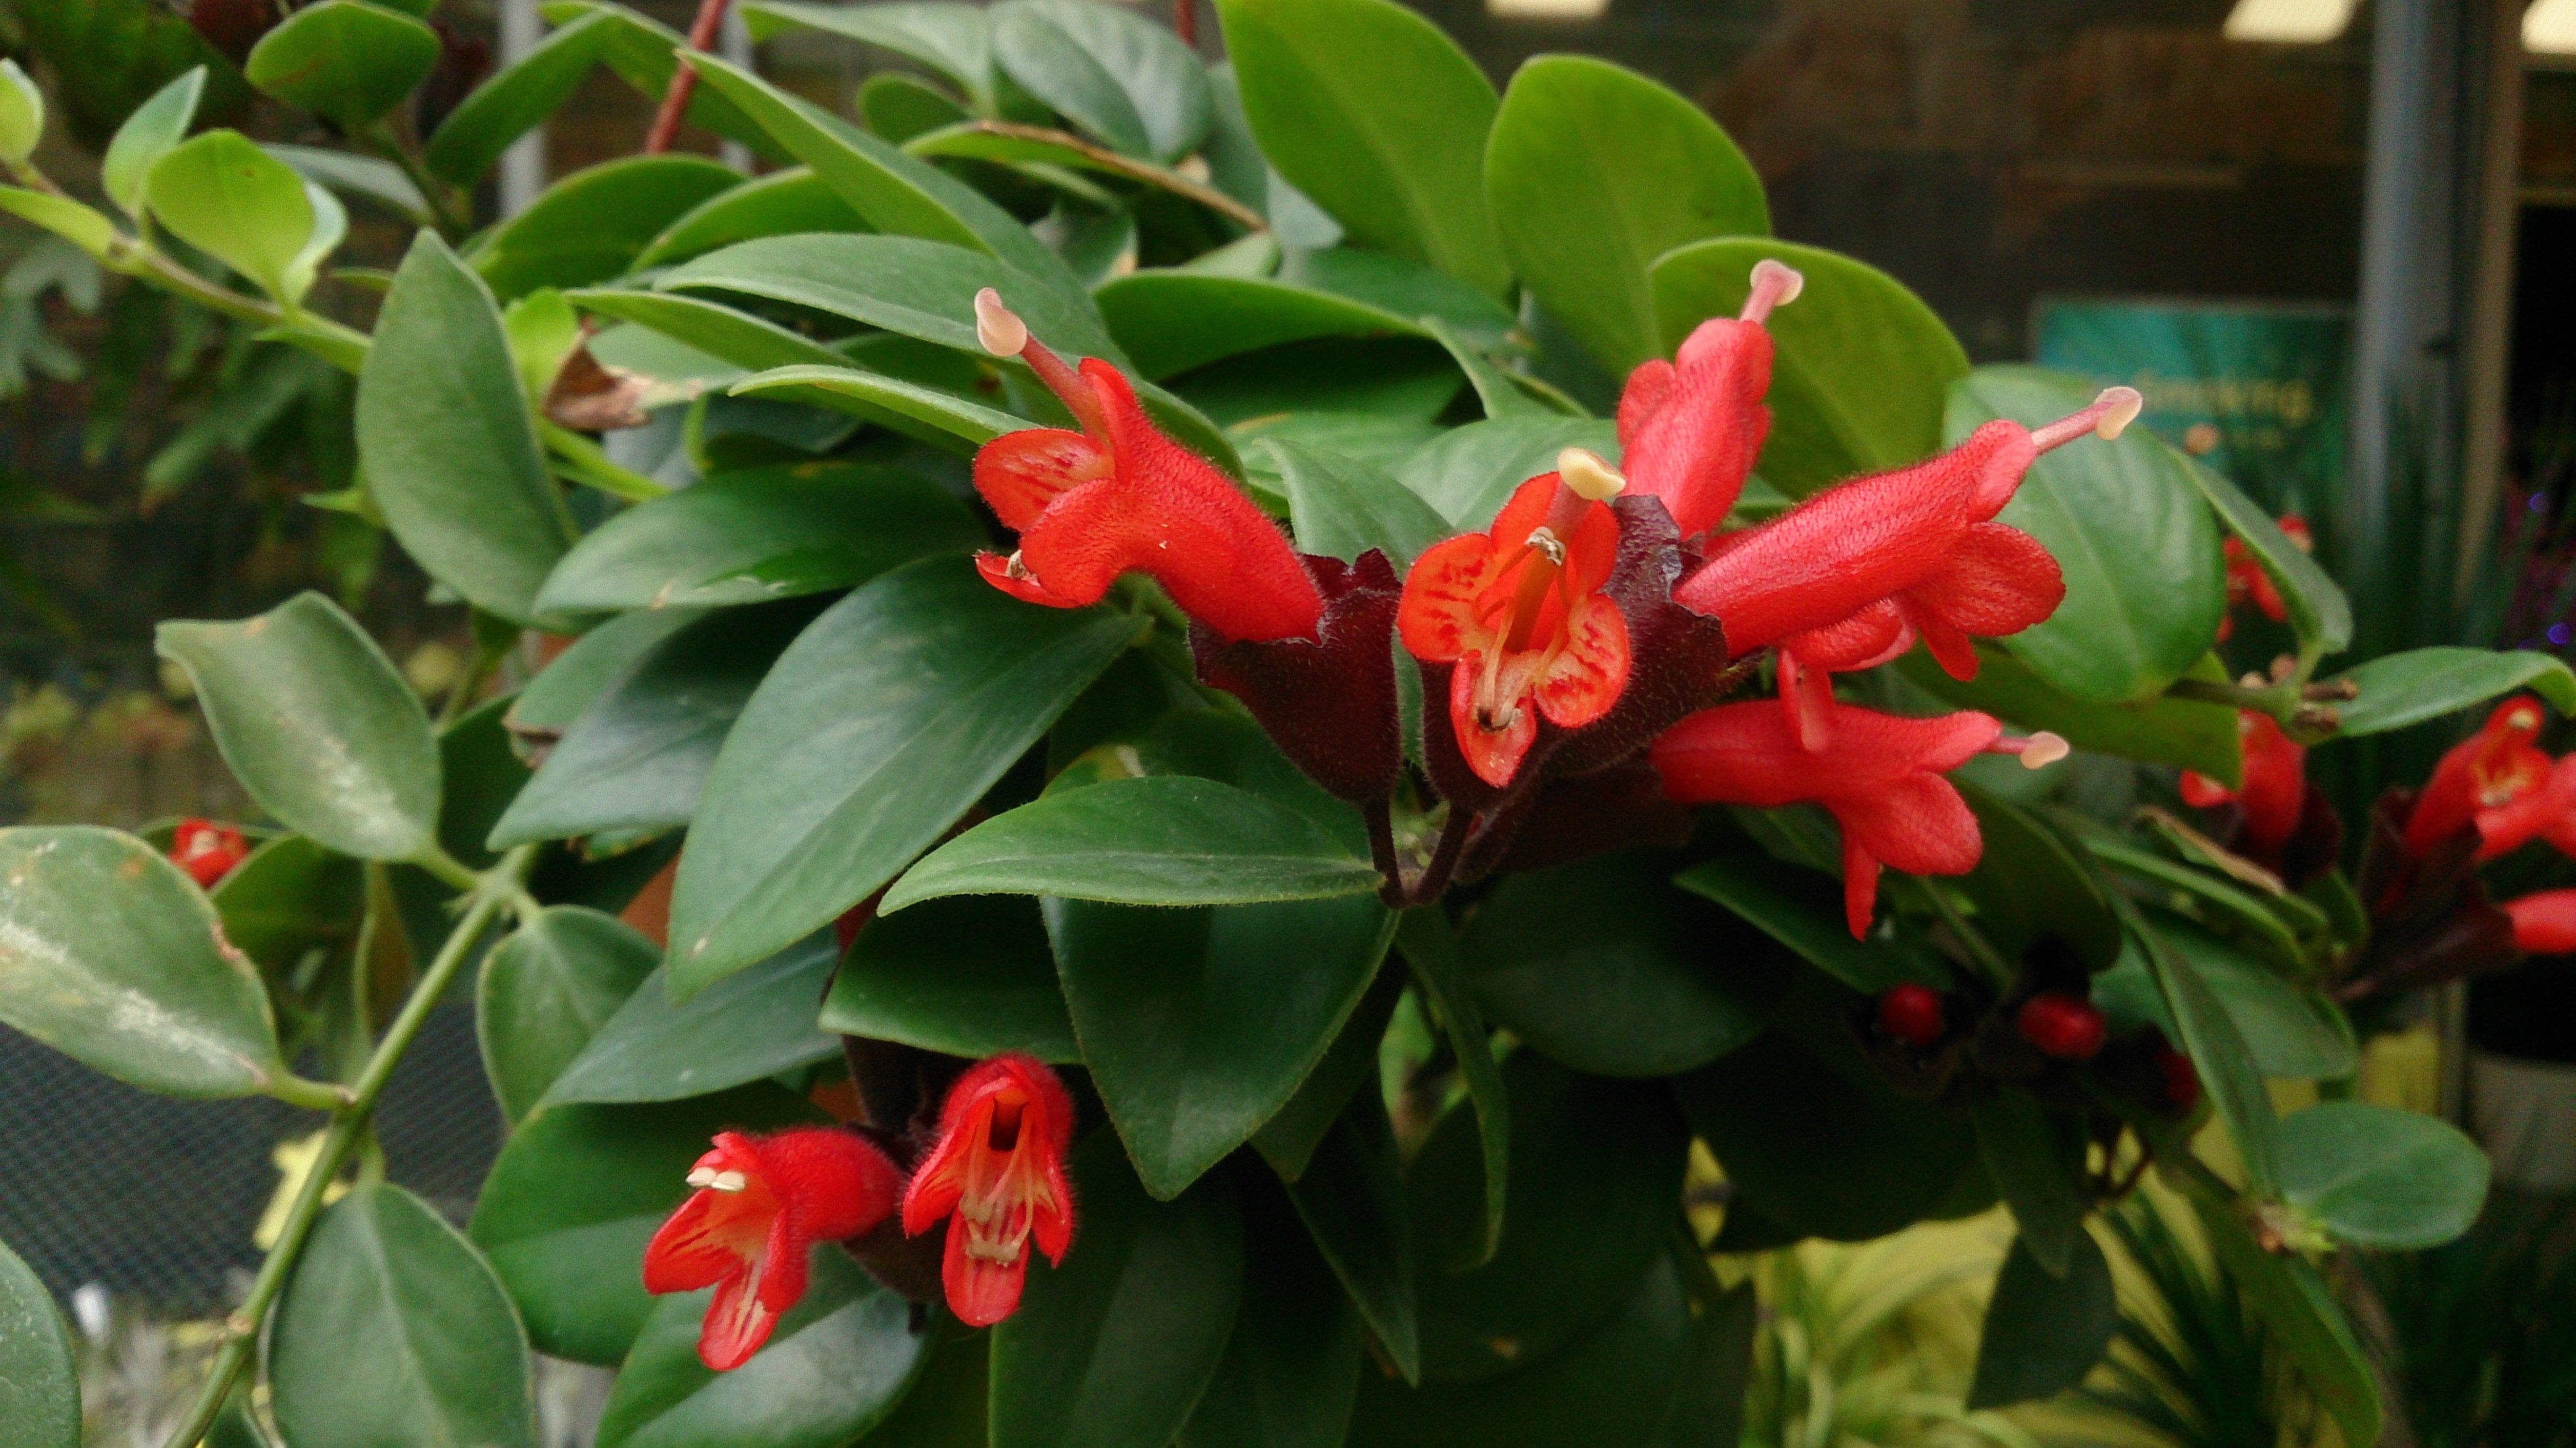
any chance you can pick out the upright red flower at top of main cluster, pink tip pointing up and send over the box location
[1618,260,1806,539]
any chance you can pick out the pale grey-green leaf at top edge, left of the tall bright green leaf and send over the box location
[992,0,1216,162]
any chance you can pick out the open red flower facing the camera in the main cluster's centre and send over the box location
[1396,448,1628,786]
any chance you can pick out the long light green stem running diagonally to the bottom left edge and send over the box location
[165,845,536,1448]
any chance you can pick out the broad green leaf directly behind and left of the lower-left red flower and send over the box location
[469,1085,821,1360]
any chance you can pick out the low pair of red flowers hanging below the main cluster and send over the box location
[644,1054,1074,1373]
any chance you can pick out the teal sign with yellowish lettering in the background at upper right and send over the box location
[2033,296,2352,518]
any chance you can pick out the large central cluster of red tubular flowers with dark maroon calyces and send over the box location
[974,275,2141,936]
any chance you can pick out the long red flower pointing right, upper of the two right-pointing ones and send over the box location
[1674,386,2143,747]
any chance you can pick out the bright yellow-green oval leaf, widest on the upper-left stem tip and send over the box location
[145,131,319,307]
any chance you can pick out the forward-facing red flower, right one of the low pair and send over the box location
[904,1051,1074,1327]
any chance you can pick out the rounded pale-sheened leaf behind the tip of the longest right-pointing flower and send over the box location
[1947,365,2228,704]
